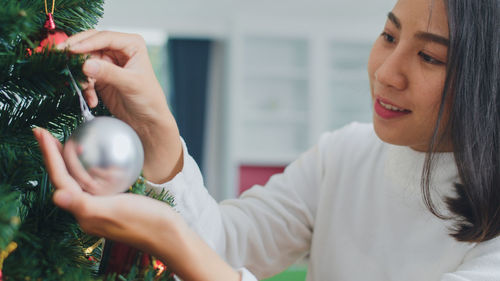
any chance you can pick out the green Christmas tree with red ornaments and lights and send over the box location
[0,0,173,281]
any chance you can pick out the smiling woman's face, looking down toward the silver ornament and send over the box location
[368,0,449,151]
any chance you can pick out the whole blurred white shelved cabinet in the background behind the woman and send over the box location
[223,22,378,198]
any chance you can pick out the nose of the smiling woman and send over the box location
[375,48,409,90]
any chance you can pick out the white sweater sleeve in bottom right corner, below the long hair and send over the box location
[441,237,500,281]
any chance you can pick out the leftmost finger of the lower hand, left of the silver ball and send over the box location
[33,128,81,191]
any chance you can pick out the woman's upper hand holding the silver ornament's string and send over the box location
[58,30,182,183]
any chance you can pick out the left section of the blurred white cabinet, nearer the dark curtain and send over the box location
[236,36,309,165]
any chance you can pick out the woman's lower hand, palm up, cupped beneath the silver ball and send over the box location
[33,128,240,281]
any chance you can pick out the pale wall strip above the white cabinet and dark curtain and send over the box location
[100,0,395,37]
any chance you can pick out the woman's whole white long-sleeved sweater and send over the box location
[147,123,500,281]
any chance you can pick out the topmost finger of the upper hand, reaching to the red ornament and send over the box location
[70,31,145,56]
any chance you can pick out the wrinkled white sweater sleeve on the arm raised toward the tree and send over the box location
[148,133,325,280]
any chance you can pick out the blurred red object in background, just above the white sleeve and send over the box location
[239,165,285,194]
